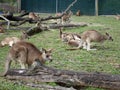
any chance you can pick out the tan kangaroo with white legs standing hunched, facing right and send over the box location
[81,30,113,51]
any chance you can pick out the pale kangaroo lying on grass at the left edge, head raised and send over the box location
[0,32,29,47]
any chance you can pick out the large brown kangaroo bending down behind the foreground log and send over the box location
[3,41,52,76]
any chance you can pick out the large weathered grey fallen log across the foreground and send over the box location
[6,66,120,90]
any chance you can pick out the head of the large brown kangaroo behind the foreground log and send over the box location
[41,48,53,61]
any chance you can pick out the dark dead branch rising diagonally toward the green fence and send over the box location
[0,0,77,26]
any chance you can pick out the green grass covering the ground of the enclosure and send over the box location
[0,13,120,90]
